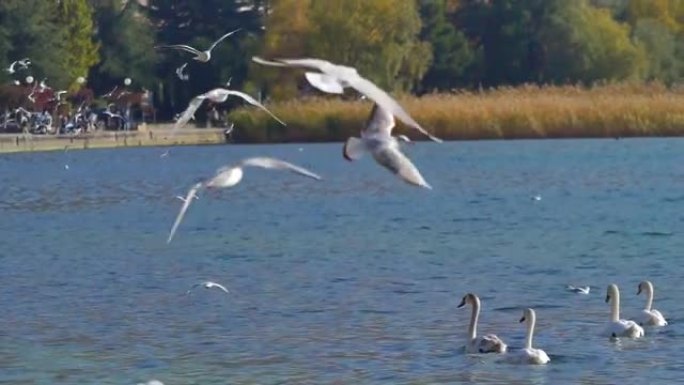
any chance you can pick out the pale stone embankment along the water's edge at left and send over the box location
[0,124,226,154]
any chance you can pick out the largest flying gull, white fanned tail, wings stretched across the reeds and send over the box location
[252,56,442,143]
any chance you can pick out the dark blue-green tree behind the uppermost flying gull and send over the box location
[145,0,265,119]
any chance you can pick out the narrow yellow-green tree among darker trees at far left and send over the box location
[57,0,99,88]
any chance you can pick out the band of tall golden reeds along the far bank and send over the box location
[229,84,684,142]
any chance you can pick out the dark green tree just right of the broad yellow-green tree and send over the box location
[419,0,478,91]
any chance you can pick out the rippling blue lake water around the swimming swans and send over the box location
[0,139,684,385]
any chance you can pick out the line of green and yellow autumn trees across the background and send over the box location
[0,0,684,118]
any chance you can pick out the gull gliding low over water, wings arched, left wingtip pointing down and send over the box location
[166,157,321,243]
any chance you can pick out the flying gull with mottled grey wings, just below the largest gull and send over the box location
[342,104,432,189]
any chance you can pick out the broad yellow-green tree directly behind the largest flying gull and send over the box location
[307,0,432,90]
